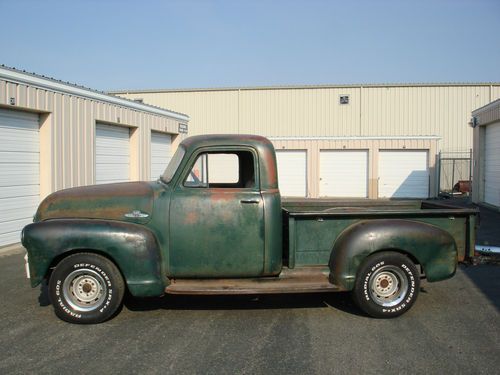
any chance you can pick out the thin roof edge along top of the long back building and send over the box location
[107,82,500,95]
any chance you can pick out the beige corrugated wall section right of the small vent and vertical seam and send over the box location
[362,86,490,151]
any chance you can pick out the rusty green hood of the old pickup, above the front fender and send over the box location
[34,182,154,223]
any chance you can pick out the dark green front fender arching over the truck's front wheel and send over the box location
[22,219,166,296]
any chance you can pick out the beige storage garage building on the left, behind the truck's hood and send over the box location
[0,67,189,250]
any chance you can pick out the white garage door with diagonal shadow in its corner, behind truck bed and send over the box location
[378,151,429,198]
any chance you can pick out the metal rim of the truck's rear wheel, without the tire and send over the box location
[368,266,408,307]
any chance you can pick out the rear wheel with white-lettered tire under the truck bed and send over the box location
[353,252,420,318]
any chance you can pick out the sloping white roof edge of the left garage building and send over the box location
[0,65,189,121]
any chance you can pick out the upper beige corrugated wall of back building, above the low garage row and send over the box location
[119,84,500,151]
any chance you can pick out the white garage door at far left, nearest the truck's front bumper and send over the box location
[0,110,40,246]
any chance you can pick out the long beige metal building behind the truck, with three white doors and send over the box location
[113,83,500,198]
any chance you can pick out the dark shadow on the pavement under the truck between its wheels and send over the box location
[124,293,366,316]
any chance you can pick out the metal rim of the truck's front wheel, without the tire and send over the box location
[63,269,107,311]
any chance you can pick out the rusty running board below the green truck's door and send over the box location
[165,267,340,295]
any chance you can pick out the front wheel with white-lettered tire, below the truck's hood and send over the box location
[49,253,125,324]
